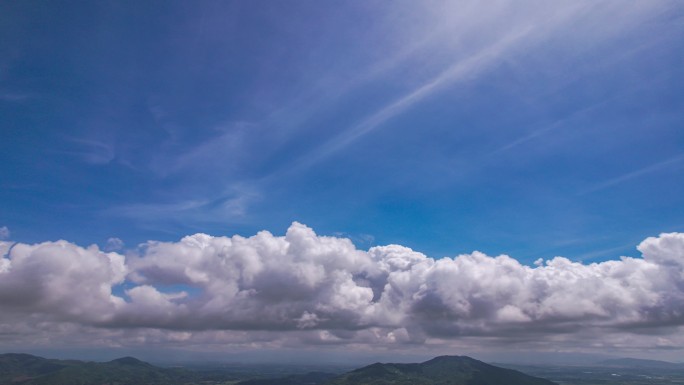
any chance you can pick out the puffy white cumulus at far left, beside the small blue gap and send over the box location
[0,241,127,323]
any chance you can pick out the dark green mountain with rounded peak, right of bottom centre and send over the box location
[328,356,555,385]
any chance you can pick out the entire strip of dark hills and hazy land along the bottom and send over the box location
[0,353,684,385]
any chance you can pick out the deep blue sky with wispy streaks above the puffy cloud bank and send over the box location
[0,1,684,263]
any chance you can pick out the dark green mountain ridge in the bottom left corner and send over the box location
[0,353,199,385]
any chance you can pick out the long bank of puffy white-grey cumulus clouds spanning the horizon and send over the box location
[0,223,684,354]
